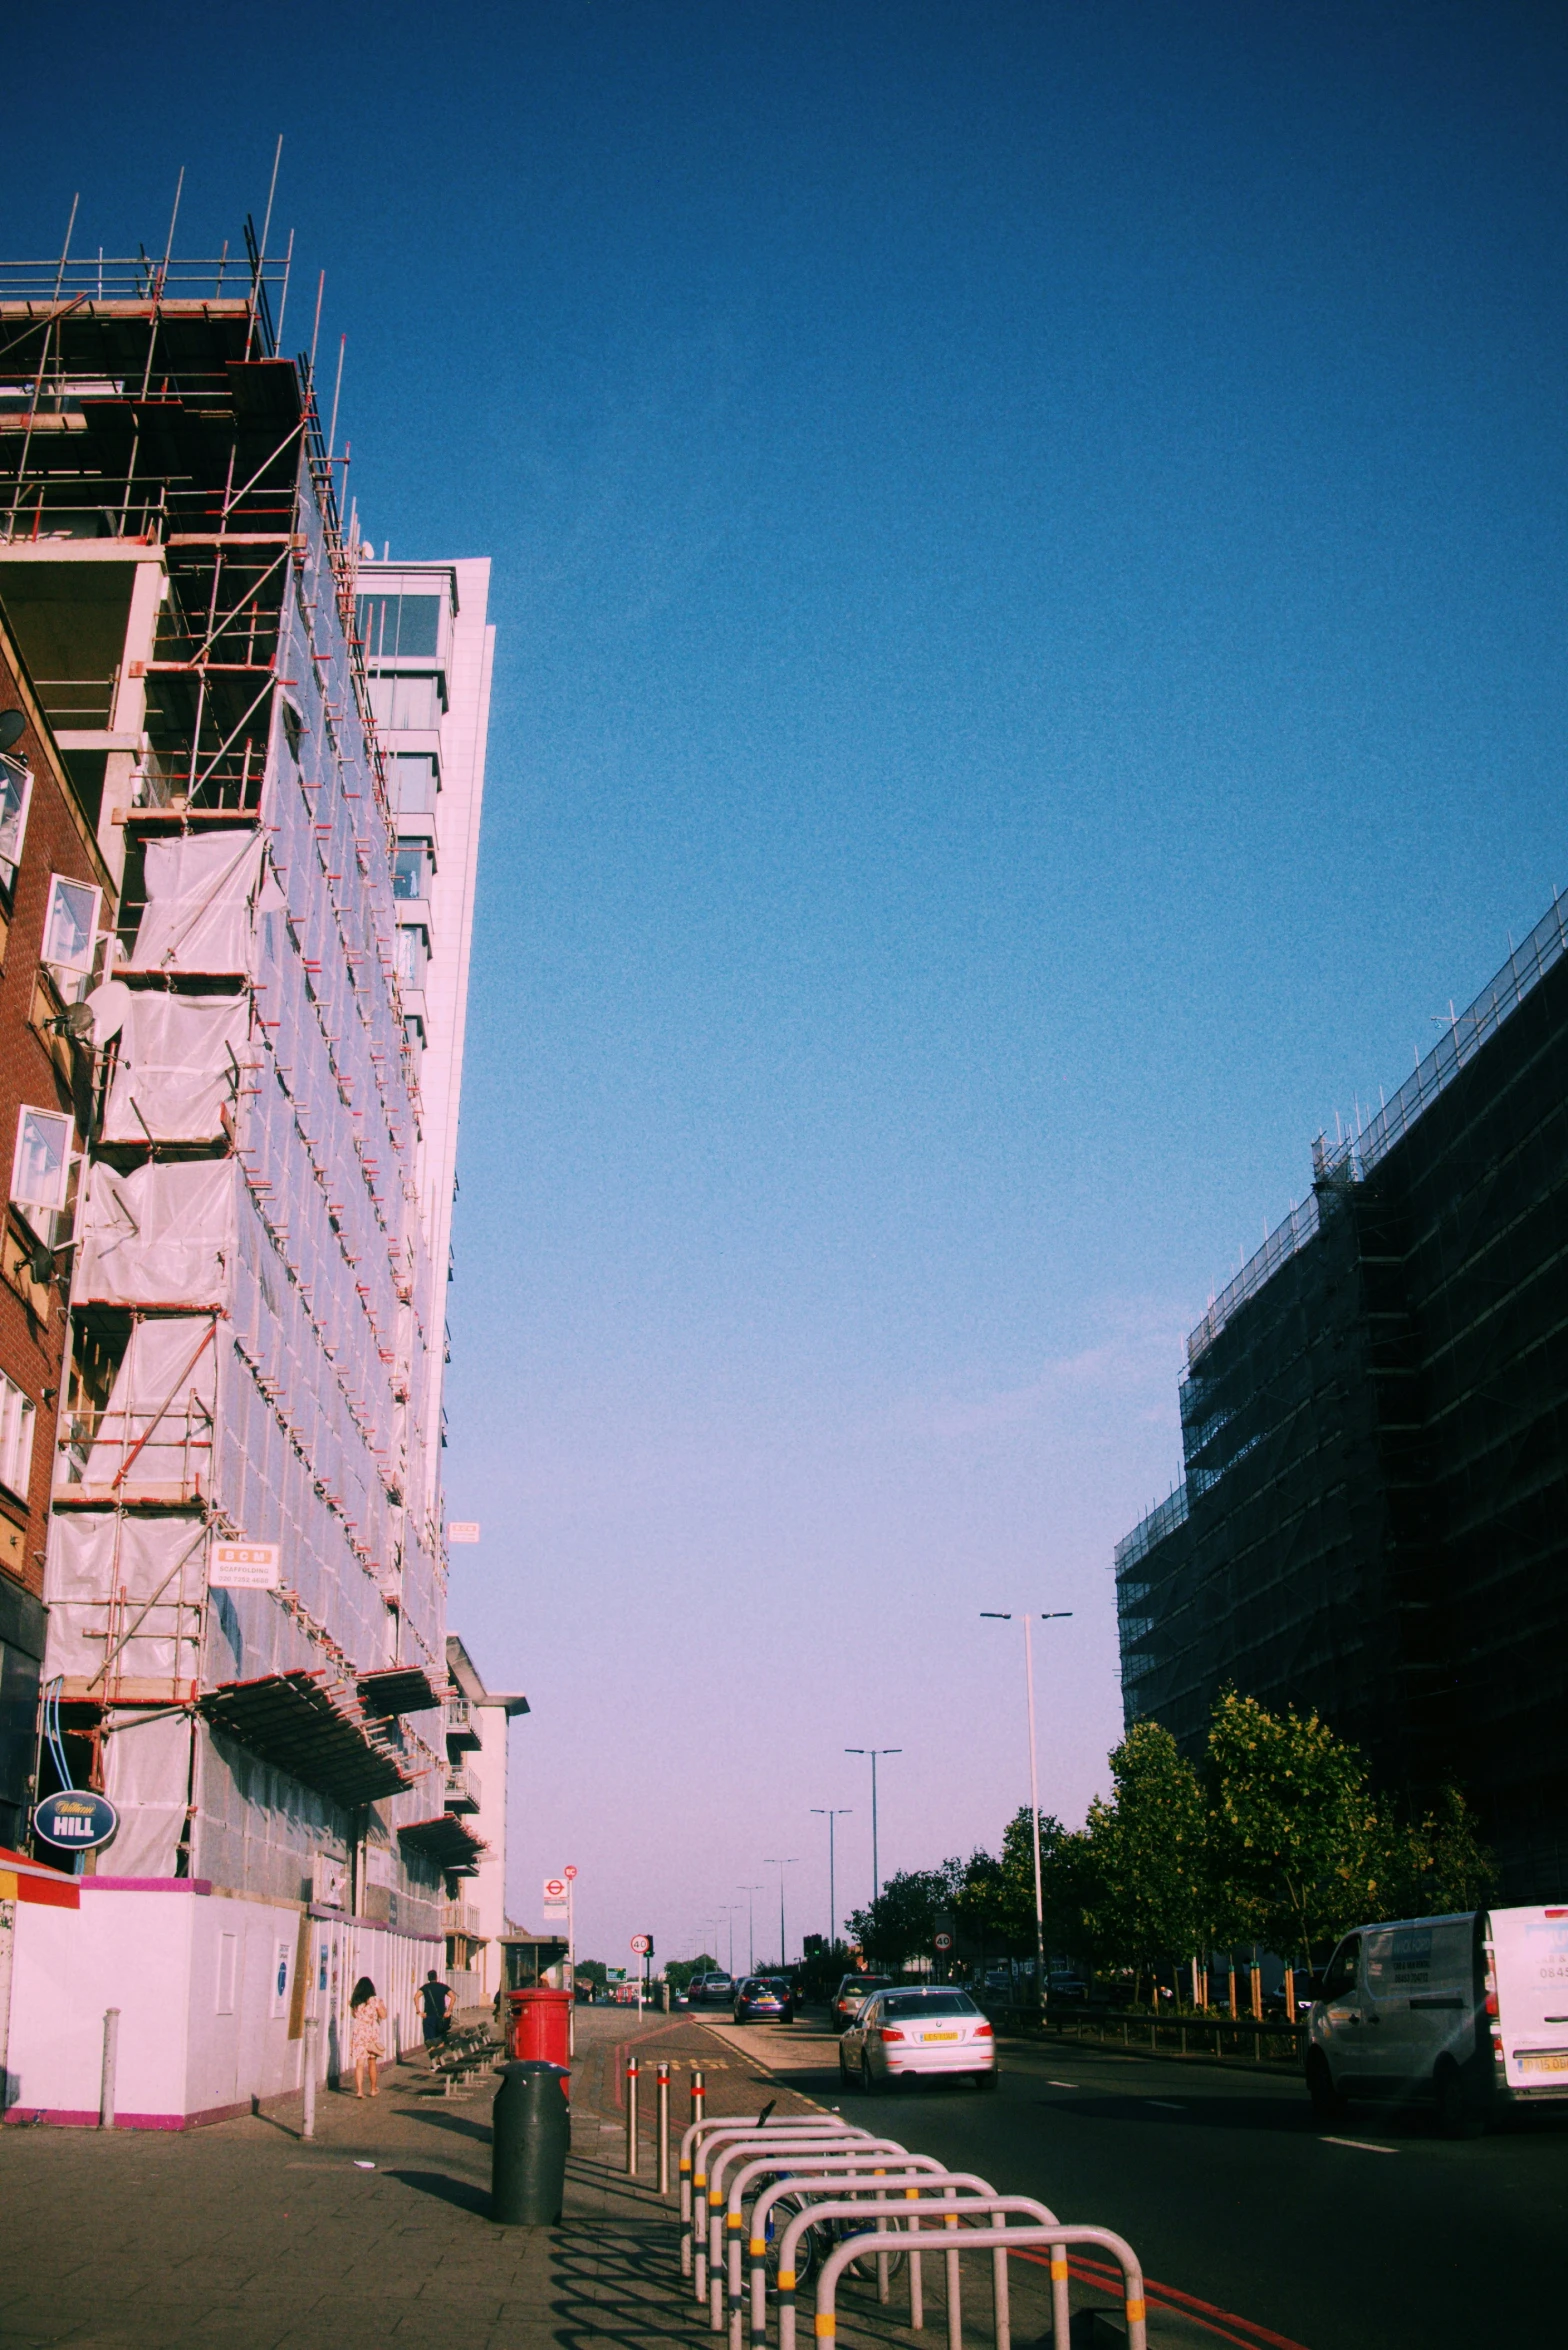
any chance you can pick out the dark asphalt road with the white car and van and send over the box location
[709,2019,1568,2350]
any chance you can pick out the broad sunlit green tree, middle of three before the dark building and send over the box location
[1208,1690,1394,1965]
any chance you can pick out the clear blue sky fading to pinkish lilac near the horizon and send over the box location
[7,0,1568,1958]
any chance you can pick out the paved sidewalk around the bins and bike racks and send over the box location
[0,2009,1180,2350]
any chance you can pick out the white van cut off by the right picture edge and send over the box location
[1307,1904,1568,2139]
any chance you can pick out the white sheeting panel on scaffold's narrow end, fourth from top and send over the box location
[82,1316,219,1502]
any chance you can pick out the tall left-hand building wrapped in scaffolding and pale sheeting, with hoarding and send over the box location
[0,230,477,2120]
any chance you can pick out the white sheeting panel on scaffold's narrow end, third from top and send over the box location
[71,1159,237,1307]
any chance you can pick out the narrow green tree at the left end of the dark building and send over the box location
[1081,1723,1211,1972]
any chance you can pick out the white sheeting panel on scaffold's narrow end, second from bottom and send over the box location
[45,1509,207,1687]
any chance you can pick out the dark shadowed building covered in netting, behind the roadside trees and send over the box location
[1117,905,1568,1901]
